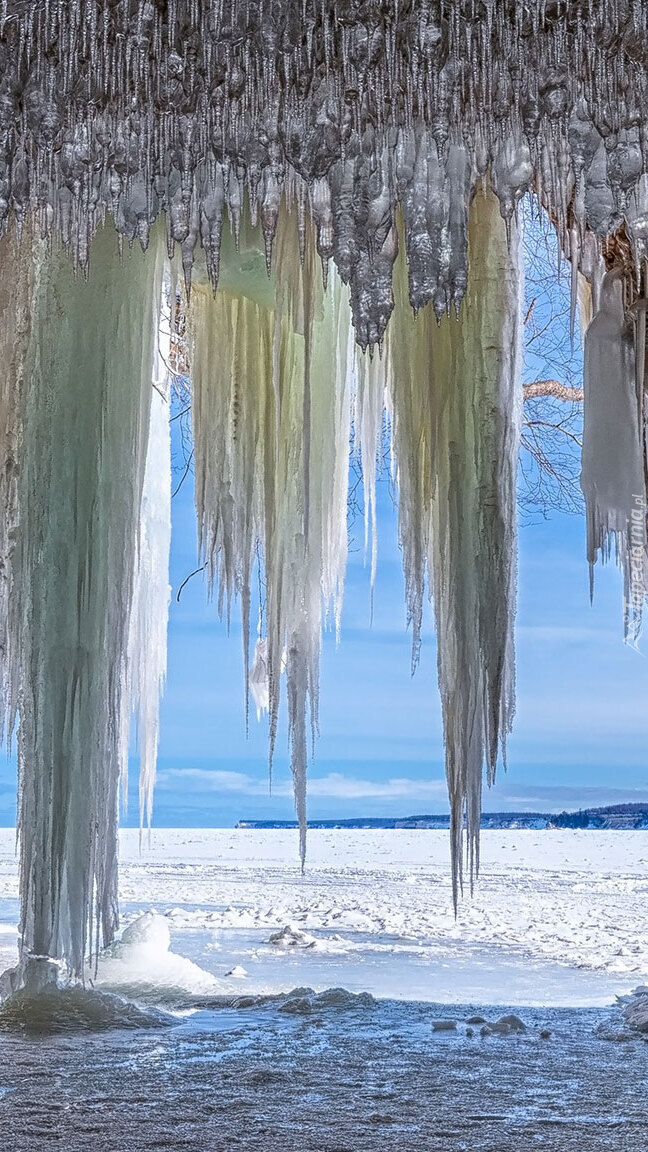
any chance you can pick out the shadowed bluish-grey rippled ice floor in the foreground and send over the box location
[0,1001,648,1152]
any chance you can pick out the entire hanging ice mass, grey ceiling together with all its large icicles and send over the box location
[0,0,648,983]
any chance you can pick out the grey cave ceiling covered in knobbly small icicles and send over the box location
[0,0,648,336]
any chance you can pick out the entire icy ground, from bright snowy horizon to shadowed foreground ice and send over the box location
[0,831,648,1152]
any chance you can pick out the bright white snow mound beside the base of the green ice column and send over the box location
[92,911,224,1008]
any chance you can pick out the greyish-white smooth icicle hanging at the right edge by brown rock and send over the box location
[581,272,648,644]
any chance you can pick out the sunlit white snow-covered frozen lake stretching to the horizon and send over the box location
[0,829,648,1006]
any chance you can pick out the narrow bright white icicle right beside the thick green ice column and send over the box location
[125,283,171,828]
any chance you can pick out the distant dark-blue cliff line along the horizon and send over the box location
[236,804,648,829]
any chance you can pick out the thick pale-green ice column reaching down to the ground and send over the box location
[15,227,161,985]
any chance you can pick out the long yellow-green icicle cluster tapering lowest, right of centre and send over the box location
[387,192,522,899]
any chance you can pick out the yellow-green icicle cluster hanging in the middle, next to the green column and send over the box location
[190,214,353,861]
